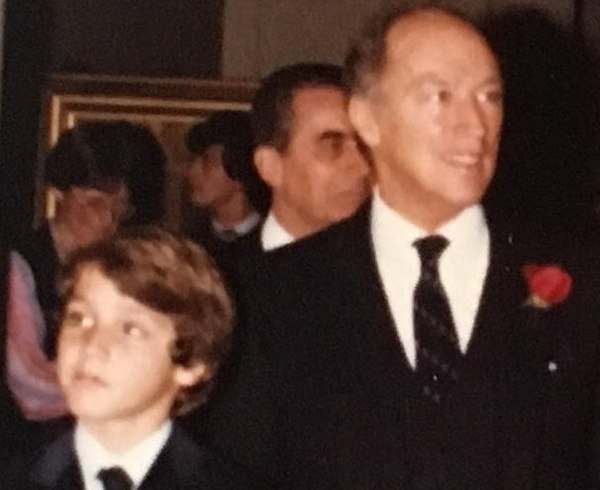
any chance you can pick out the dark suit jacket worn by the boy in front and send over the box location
[3,425,257,490]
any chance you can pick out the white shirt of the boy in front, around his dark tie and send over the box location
[75,420,173,490]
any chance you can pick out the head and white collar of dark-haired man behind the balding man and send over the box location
[251,63,371,251]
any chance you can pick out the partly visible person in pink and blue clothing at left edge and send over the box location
[0,244,67,468]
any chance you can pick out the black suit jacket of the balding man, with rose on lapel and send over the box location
[207,201,600,490]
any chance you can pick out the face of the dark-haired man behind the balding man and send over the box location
[272,87,370,231]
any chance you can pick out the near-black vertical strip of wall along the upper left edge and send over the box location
[0,0,52,241]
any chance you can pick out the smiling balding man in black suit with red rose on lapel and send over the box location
[215,7,600,490]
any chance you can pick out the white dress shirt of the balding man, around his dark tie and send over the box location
[371,190,490,368]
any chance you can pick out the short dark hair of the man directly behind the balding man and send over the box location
[251,63,348,151]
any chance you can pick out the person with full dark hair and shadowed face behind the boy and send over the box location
[17,121,166,356]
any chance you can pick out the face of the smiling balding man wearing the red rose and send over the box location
[358,11,503,229]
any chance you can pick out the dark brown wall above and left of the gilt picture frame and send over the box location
[0,0,223,241]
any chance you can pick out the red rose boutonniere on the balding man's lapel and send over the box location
[523,264,573,310]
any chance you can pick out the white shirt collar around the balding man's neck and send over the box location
[371,189,487,254]
